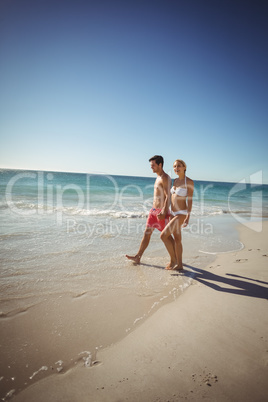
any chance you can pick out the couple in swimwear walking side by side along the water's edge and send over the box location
[126,155,194,270]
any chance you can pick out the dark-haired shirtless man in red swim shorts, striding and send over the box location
[126,155,173,264]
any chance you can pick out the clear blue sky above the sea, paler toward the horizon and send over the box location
[0,0,268,183]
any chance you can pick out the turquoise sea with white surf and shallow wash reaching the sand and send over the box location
[0,170,268,400]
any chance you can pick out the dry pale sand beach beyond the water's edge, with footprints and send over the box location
[5,222,268,402]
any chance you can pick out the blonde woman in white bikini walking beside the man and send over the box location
[161,159,194,270]
